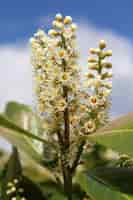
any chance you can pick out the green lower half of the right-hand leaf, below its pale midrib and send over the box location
[87,129,133,157]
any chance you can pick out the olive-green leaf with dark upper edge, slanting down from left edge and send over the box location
[0,115,47,161]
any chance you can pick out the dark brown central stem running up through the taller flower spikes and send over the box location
[58,34,72,200]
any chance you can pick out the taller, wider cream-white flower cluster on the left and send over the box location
[30,14,79,135]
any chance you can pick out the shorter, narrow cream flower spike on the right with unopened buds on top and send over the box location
[84,40,112,133]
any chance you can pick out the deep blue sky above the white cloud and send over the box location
[0,0,133,43]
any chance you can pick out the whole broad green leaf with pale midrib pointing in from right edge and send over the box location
[83,112,133,157]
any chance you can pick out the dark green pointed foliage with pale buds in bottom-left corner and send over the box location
[1,147,46,200]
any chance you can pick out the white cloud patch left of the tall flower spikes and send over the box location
[0,45,32,109]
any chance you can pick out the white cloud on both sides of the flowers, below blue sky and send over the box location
[0,22,133,116]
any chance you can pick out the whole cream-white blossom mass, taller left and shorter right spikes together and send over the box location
[30,14,112,135]
